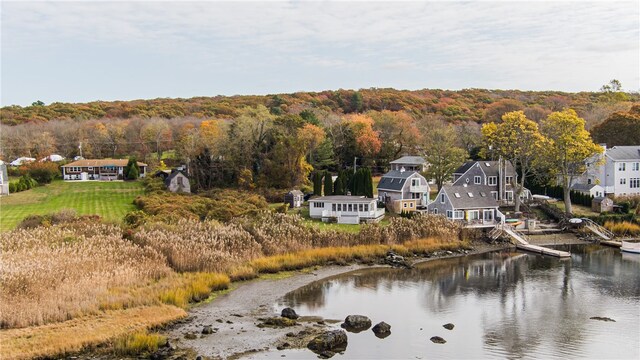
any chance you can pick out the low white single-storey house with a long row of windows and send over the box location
[309,195,384,224]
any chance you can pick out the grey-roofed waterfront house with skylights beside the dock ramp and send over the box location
[427,184,504,227]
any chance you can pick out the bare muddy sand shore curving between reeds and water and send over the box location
[164,243,511,358]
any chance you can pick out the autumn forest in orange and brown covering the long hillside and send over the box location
[0,86,640,193]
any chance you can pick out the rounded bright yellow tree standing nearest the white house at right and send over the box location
[540,109,603,214]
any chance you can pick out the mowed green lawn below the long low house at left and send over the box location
[0,180,144,231]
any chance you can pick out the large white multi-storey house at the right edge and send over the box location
[572,144,640,196]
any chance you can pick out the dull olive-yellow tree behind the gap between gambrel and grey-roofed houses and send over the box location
[423,122,468,190]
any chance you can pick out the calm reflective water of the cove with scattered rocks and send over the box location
[254,245,640,359]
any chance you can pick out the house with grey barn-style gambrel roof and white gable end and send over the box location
[378,167,429,213]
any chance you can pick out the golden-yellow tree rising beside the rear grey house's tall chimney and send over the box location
[482,111,544,212]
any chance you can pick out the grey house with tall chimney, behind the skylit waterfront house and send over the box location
[453,160,531,205]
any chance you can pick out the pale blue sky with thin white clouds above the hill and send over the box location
[0,0,640,106]
